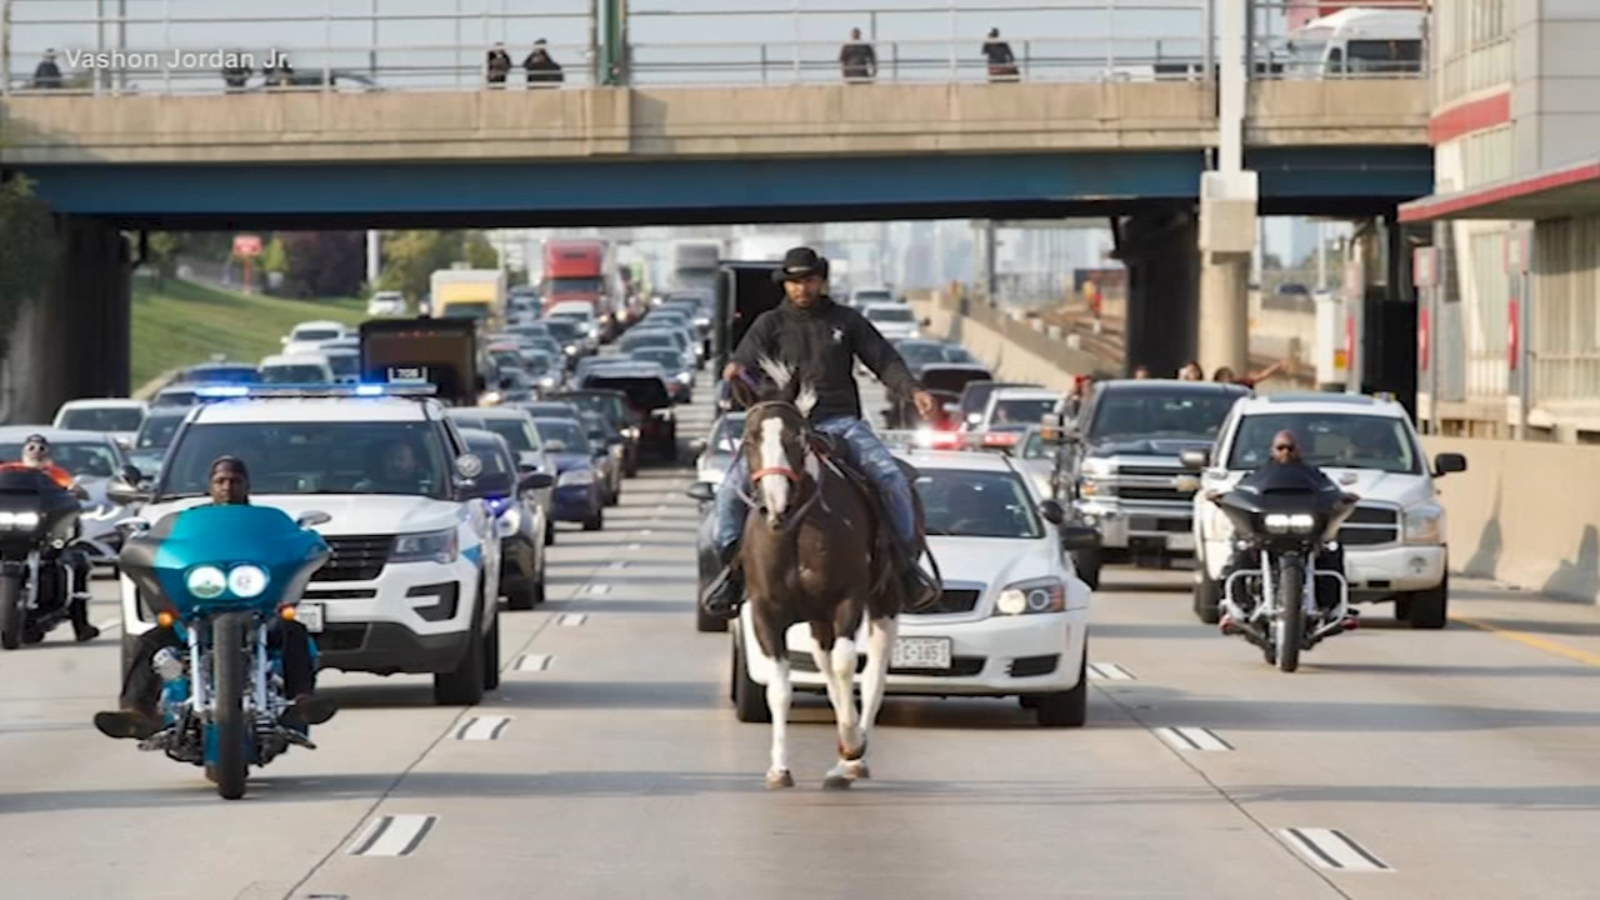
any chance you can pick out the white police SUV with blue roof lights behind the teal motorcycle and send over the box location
[118,384,517,705]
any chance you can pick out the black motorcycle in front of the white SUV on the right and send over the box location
[1213,466,1358,673]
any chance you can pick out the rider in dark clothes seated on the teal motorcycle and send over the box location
[94,456,338,740]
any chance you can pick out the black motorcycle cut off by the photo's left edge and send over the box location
[0,469,90,650]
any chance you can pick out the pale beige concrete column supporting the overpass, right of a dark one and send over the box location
[1197,171,1258,376]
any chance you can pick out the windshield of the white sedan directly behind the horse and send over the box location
[917,469,1045,540]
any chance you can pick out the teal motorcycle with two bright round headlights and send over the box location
[118,506,331,799]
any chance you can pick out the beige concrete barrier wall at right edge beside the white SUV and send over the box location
[1422,437,1600,604]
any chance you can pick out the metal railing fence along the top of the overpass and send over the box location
[0,0,1422,94]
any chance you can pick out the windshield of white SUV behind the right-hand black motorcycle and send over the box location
[1227,413,1422,476]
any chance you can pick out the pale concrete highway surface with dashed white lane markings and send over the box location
[0,389,1600,900]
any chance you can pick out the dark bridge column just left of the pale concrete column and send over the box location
[1117,208,1200,378]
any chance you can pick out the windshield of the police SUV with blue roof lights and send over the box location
[155,421,450,500]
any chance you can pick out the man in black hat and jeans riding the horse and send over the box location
[701,247,941,618]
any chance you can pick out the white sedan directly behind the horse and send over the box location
[733,450,1096,727]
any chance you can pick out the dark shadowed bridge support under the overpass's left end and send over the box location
[0,216,133,423]
